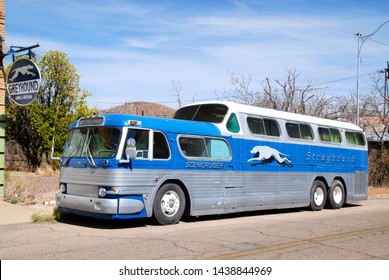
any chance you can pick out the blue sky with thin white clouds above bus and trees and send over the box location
[5,0,389,108]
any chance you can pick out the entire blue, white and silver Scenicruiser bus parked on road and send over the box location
[56,101,368,224]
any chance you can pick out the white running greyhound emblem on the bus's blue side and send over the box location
[247,146,292,166]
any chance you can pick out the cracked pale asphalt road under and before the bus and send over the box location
[0,198,389,260]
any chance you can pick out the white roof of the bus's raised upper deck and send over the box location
[180,101,362,131]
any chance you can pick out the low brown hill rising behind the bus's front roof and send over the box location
[102,101,176,118]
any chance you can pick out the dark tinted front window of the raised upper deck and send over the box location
[174,104,228,123]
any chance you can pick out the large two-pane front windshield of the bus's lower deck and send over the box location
[63,127,120,159]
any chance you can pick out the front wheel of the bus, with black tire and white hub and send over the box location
[153,184,186,225]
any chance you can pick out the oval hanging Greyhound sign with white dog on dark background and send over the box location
[7,58,41,106]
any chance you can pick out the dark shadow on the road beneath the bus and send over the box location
[57,204,361,230]
